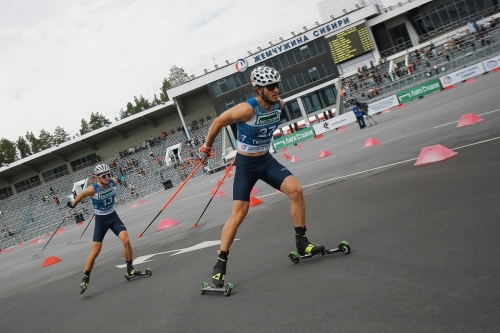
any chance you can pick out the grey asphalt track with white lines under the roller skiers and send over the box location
[0,73,500,333]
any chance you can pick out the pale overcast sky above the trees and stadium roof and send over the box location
[0,0,398,141]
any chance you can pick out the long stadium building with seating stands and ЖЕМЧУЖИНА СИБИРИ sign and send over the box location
[0,0,500,244]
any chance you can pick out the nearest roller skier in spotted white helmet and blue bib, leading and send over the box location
[200,66,325,288]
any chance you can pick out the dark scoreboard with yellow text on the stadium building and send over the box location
[326,24,374,64]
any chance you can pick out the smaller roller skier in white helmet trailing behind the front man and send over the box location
[67,164,141,293]
